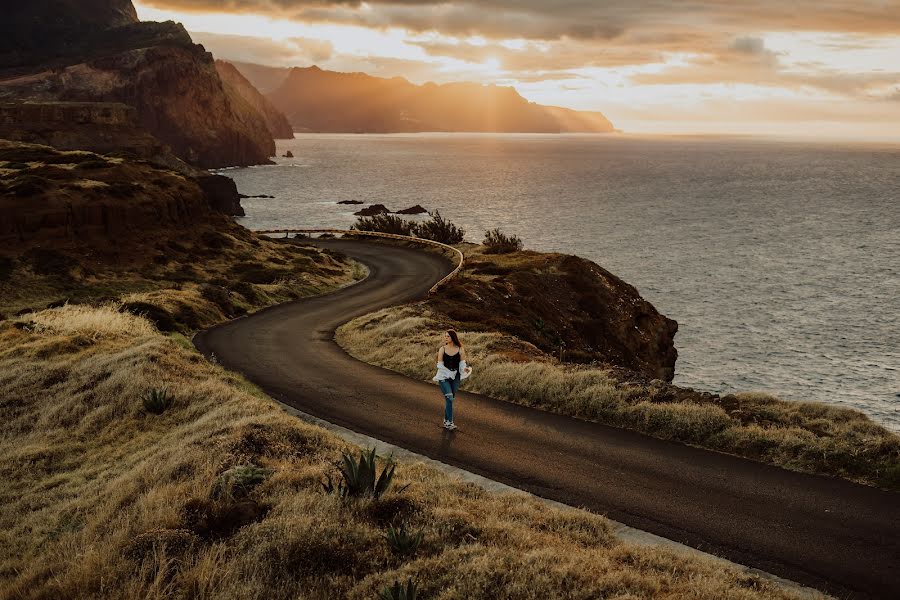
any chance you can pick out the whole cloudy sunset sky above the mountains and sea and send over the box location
[135,0,900,139]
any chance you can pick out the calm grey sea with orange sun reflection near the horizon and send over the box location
[224,134,900,430]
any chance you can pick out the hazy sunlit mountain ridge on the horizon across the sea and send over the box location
[236,63,614,133]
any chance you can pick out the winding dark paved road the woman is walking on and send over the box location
[195,240,900,598]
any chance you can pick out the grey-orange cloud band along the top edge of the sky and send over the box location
[143,0,900,40]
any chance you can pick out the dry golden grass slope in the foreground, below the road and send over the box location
[0,307,812,600]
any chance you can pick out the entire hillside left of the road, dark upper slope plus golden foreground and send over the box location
[0,148,824,600]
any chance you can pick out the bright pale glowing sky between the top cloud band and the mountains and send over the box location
[135,0,900,136]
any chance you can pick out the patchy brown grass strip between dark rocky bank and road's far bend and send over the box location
[0,231,365,333]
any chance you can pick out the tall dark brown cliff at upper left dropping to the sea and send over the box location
[0,0,275,168]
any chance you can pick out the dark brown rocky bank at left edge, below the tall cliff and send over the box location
[0,140,239,248]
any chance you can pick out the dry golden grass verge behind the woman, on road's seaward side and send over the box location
[337,304,900,490]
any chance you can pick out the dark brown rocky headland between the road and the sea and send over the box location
[427,251,678,381]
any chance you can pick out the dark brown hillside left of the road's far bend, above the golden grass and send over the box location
[0,141,362,324]
